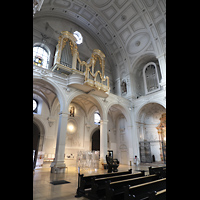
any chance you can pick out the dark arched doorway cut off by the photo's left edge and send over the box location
[33,123,40,170]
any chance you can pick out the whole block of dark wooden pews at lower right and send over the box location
[75,167,166,200]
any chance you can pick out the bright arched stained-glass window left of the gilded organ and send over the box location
[33,44,50,69]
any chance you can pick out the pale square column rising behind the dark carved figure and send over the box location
[100,120,108,163]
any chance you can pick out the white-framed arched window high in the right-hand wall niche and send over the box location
[143,62,160,94]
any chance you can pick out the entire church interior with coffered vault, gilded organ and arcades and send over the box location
[33,0,166,200]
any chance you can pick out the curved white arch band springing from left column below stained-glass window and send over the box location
[33,76,67,112]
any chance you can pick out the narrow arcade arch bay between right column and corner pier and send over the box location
[108,104,133,165]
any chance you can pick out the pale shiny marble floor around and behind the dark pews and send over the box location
[33,162,165,200]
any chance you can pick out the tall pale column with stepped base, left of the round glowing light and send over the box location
[51,112,68,173]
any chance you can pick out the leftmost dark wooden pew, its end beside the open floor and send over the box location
[75,169,132,197]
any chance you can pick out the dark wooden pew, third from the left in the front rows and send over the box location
[106,174,159,200]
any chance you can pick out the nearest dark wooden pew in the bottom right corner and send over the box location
[124,178,166,200]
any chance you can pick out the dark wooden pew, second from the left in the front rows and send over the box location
[88,171,145,200]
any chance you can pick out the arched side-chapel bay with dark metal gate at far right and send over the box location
[136,102,166,162]
